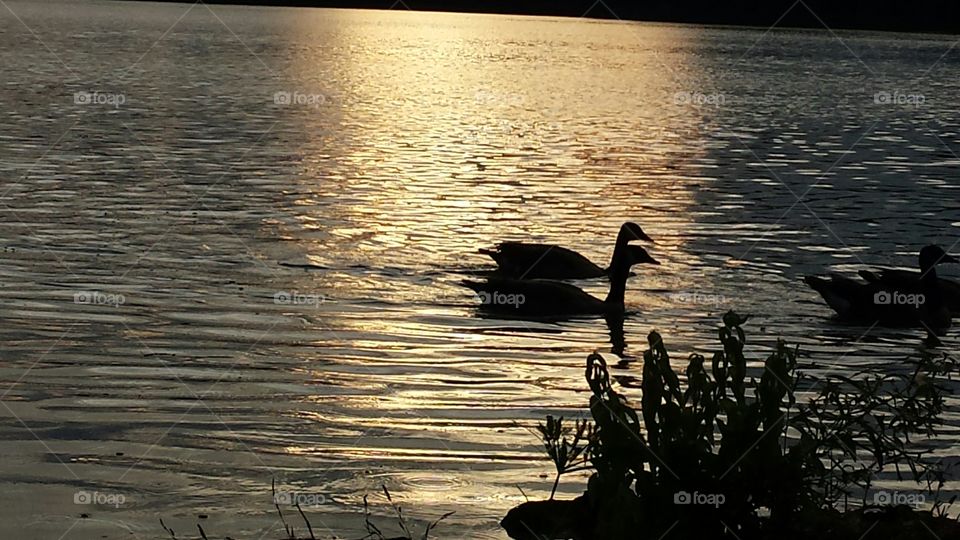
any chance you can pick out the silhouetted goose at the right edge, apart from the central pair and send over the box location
[804,246,960,335]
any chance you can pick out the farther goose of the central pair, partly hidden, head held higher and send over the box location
[480,221,653,279]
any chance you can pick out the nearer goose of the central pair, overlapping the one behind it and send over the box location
[463,246,660,317]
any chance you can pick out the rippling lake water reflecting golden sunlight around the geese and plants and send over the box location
[0,0,960,539]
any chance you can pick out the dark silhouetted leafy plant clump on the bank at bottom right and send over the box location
[502,312,960,540]
